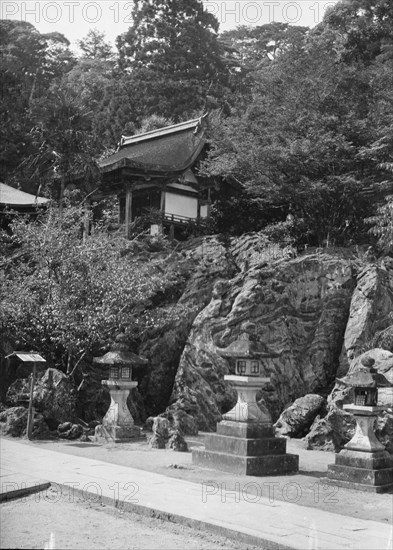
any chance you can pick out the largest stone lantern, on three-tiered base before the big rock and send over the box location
[192,323,299,476]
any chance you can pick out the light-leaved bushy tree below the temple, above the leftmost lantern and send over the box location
[0,207,188,371]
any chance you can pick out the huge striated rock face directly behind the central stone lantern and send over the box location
[168,246,355,430]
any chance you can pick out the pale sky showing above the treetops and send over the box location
[0,0,338,48]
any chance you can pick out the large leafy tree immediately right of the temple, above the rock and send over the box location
[202,19,387,245]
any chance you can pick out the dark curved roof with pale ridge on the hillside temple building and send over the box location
[100,117,206,174]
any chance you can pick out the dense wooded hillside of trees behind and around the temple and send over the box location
[0,0,393,246]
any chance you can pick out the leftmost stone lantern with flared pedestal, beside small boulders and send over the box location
[93,334,147,443]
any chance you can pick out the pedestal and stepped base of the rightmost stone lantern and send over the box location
[321,405,393,493]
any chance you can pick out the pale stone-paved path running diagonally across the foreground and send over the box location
[1,439,392,550]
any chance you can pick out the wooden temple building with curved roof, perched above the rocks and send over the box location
[100,115,222,235]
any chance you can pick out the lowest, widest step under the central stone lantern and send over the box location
[192,448,299,476]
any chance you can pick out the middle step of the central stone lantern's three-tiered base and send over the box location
[204,434,287,456]
